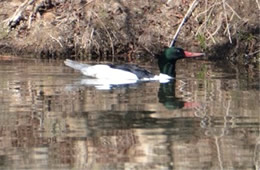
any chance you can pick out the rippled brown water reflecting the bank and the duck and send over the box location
[0,57,260,170]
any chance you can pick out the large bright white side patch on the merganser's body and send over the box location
[81,65,138,80]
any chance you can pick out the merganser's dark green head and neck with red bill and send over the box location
[158,47,205,77]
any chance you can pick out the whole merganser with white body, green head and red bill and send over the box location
[64,47,205,84]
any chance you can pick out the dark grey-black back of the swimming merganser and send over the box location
[109,64,154,79]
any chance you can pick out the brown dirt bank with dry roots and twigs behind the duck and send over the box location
[0,0,260,68]
